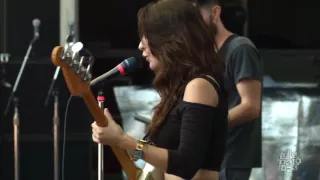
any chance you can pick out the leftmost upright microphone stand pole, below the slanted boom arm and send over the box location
[13,98,20,180]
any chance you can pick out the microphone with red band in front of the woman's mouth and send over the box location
[90,57,137,86]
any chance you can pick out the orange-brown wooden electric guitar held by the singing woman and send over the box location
[51,42,158,180]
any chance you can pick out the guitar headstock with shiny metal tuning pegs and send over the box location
[51,42,94,96]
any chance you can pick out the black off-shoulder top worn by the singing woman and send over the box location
[145,75,228,179]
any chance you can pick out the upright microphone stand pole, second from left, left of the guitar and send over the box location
[53,90,60,180]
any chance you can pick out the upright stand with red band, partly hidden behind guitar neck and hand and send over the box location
[97,90,104,180]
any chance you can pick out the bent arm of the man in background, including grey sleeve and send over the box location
[228,45,263,126]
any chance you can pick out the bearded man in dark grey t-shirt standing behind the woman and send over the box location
[192,0,263,180]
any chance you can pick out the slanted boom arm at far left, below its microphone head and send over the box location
[4,36,39,116]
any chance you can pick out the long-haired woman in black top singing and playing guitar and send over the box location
[92,0,228,180]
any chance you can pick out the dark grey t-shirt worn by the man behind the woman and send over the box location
[219,35,263,168]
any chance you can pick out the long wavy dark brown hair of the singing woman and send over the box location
[138,0,224,139]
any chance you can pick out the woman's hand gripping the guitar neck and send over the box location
[91,109,125,147]
